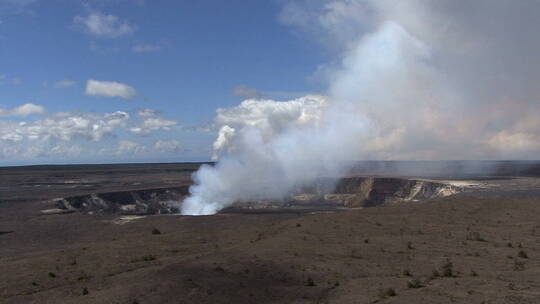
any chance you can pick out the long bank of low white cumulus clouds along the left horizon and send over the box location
[0,105,189,163]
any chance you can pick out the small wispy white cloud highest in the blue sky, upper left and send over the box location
[73,13,135,38]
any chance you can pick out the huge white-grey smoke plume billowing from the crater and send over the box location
[182,0,540,215]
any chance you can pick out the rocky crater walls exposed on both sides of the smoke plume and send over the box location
[50,177,460,215]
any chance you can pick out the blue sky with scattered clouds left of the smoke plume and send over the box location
[0,0,325,165]
